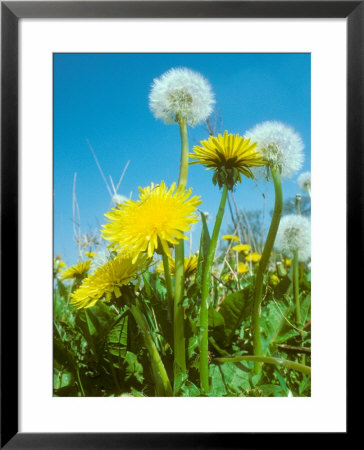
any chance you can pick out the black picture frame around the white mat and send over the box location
[1,1,358,449]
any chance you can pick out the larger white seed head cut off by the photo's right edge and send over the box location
[275,214,311,262]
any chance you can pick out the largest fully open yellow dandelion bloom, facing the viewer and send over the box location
[102,181,201,260]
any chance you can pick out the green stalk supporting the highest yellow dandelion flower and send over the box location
[200,185,228,394]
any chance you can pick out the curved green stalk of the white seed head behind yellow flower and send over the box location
[252,166,283,374]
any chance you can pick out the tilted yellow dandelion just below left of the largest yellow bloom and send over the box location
[70,254,148,309]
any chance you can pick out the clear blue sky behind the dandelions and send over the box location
[54,53,311,264]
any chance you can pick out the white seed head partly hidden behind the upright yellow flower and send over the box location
[245,121,304,178]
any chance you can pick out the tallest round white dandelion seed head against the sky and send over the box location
[149,67,215,126]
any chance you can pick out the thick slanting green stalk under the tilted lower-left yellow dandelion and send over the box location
[130,304,173,397]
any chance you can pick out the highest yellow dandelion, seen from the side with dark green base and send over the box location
[190,131,267,190]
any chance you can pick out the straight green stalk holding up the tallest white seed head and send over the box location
[173,119,188,386]
